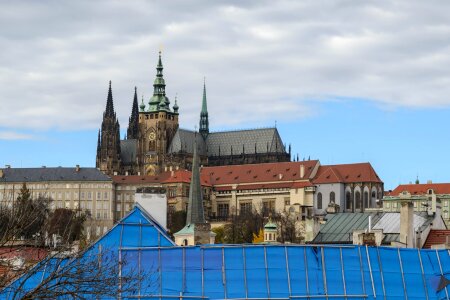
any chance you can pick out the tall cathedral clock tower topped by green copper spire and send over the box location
[137,52,178,175]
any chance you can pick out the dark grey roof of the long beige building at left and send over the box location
[0,167,111,183]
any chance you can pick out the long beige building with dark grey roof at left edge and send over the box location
[0,166,114,239]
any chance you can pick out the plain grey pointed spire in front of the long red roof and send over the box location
[186,136,205,225]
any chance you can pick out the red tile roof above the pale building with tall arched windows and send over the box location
[313,163,382,184]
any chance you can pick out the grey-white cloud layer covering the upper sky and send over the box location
[0,0,450,130]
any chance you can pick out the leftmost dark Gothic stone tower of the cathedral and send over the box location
[95,81,120,175]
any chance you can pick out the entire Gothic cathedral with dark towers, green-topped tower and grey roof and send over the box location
[96,52,291,175]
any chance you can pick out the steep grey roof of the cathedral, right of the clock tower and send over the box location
[169,128,286,156]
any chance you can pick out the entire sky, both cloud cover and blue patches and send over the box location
[0,0,450,189]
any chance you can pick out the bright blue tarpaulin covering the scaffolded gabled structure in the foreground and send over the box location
[3,206,450,299]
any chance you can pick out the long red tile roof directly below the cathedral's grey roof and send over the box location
[201,160,319,185]
